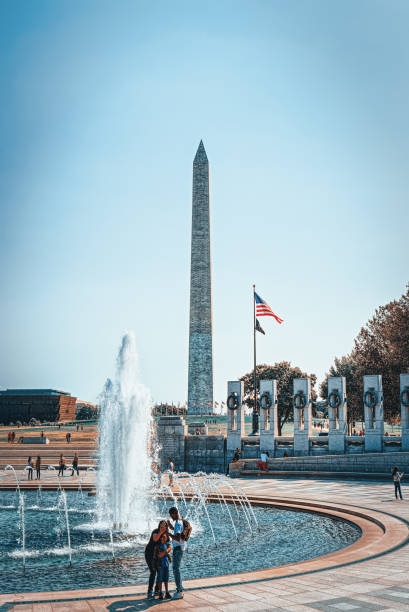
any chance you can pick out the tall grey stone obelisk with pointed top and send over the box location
[188,141,213,414]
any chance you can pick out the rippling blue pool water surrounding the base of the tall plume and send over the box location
[0,492,361,593]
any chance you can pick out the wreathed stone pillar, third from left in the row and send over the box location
[293,378,312,457]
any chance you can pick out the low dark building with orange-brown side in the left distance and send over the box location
[0,389,77,425]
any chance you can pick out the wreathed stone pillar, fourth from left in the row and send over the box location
[328,376,347,455]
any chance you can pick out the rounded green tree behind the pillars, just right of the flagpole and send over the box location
[240,361,317,436]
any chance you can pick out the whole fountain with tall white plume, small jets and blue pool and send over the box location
[0,333,359,592]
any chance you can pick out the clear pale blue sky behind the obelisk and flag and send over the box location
[0,0,409,402]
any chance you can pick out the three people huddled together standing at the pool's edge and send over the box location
[145,507,192,599]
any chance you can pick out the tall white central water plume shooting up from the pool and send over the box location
[97,332,152,533]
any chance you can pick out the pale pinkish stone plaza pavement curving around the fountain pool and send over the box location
[0,478,409,612]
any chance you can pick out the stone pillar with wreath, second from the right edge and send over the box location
[363,374,384,453]
